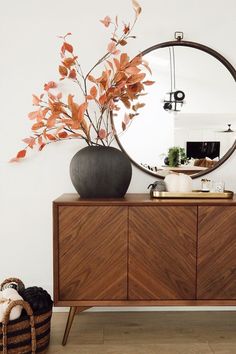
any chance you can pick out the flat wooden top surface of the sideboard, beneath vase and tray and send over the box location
[54,193,236,206]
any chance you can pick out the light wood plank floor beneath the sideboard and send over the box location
[48,312,236,354]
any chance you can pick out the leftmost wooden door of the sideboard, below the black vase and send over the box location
[58,206,128,300]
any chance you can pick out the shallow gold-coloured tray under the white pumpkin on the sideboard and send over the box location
[151,190,234,199]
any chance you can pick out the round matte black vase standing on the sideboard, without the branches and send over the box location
[70,146,132,198]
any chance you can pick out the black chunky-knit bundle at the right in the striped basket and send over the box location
[21,286,52,312]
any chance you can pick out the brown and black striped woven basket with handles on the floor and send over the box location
[0,278,52,354]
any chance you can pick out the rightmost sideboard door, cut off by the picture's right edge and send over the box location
[197,206,236,299]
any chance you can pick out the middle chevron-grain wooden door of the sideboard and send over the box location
[128,206,197,300]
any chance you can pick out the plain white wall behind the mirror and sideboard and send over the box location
[0,0,236,306]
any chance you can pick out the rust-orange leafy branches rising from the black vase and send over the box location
[11,0,153,161]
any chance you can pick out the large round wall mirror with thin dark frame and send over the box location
[113,40,236,178]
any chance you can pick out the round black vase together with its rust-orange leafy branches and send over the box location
[11,0,153,197]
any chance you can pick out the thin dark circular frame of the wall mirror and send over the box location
[111,38,236,179]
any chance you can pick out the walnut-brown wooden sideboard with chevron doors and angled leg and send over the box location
[53,194,236,344]
